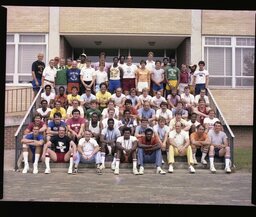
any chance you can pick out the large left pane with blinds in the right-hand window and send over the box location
[207,47,224,76]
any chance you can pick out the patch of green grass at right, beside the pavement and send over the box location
[234,147,252,172]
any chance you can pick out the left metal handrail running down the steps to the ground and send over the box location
[14,87,43,171]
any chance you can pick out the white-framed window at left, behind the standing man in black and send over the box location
[6,34,47,84]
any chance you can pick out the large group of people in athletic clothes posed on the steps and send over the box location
[21,52,231,175]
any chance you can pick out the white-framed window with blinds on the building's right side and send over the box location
[203,37,255,87]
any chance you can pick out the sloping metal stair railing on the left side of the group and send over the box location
[14,88,43,171]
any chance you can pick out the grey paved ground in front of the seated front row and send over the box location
[3,151,254,206]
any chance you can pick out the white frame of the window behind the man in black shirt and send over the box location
[6,33,48,87]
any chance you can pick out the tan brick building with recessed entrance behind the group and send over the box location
[5,6,255,147]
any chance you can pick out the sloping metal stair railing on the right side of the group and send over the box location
[207,89,235,167]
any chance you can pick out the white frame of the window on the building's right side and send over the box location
[202,36,255,88]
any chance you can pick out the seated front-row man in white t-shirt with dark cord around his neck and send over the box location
[114,127,139,175]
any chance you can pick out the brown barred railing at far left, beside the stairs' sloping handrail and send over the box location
[5,87,34,113]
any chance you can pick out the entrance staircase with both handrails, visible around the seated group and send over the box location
[15,89,235,173]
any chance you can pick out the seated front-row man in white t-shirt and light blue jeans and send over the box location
[74,130,102,175]
